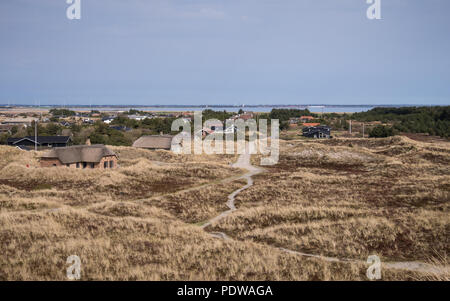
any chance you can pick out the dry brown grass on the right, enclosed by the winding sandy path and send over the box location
[211,137,450,270]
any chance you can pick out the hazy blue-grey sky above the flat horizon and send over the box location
[0,0,450,105]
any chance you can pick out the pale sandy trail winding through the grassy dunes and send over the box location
[201,150,450,275]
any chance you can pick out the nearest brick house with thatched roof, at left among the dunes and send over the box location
[40,144,118,169]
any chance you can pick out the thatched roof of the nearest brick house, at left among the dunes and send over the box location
[41,144,117,164]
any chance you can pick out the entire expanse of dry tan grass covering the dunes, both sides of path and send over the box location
[0,137,450,280]
